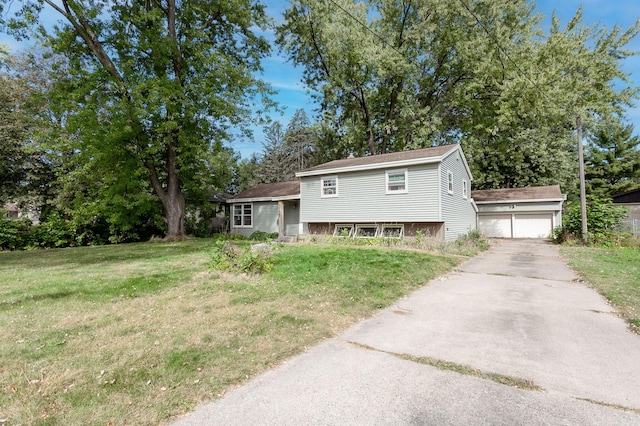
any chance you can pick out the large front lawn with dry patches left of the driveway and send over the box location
[0,240,462,425]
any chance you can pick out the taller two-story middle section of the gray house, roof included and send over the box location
[296,145,476,240]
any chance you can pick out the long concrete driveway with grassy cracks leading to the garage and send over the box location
[175,240,640,425]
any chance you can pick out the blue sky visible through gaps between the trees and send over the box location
[0,0,640,158]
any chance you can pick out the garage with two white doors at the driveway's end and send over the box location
[471,185,564,238]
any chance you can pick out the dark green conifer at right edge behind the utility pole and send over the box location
[585,119,640,197]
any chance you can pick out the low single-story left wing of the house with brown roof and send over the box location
[227,180,300,237]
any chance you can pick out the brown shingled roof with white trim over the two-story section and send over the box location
[296,144,471,177]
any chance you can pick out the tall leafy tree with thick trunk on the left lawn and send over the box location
[0,0,269,238]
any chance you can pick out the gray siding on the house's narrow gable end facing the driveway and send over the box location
[440,150,476,241]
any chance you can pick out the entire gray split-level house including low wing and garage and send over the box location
[228,144,562,241]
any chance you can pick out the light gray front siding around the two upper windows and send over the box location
[300,164,440,223]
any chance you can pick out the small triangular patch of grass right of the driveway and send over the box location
[560,247,640,331]
